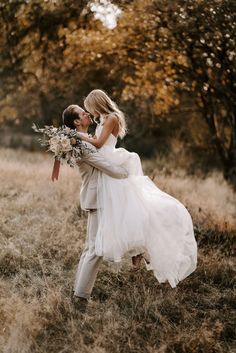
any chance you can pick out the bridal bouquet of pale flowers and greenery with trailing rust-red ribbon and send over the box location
[32,124,94,181]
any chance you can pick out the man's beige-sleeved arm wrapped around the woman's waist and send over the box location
[80,152,128,179]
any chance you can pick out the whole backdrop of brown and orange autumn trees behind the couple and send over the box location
[0,0,236,182]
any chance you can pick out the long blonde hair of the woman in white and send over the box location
[84,89,127,138]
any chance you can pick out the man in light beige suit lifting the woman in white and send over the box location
[62,105,128,300]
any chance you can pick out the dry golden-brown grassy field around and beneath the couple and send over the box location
[0,149,236,353]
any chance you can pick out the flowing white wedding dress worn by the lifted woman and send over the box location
[95,118,197,287]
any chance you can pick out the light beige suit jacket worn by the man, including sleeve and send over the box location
[77,148,128,210]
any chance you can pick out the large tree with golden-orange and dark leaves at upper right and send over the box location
[94,0,236,181]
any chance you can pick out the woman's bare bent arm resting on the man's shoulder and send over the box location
[78,116,118,148]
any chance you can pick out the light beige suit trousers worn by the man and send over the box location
[74,210,102,299]
